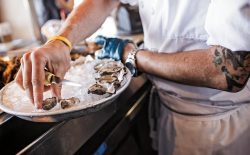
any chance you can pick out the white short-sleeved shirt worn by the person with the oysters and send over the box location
[121,0,250,103]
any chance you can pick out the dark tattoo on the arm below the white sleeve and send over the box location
[213,46,250,92]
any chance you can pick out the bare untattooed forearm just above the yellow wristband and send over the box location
[59,0,119,44]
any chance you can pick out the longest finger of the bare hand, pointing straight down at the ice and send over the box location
[31,51,46,109]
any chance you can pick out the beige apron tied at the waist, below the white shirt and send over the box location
[150,87,250,155]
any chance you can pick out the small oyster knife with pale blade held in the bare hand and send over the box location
[45,70,82,87]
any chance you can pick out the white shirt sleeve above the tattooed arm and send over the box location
[205,0,250,51]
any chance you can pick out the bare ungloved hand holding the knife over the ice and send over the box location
[15,40,70,109]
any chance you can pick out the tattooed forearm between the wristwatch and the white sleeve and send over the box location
[124,46,250,92]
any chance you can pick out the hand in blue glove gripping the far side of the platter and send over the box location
[95,36,135,61]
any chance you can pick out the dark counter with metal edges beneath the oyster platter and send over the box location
[0,75,151,155]
